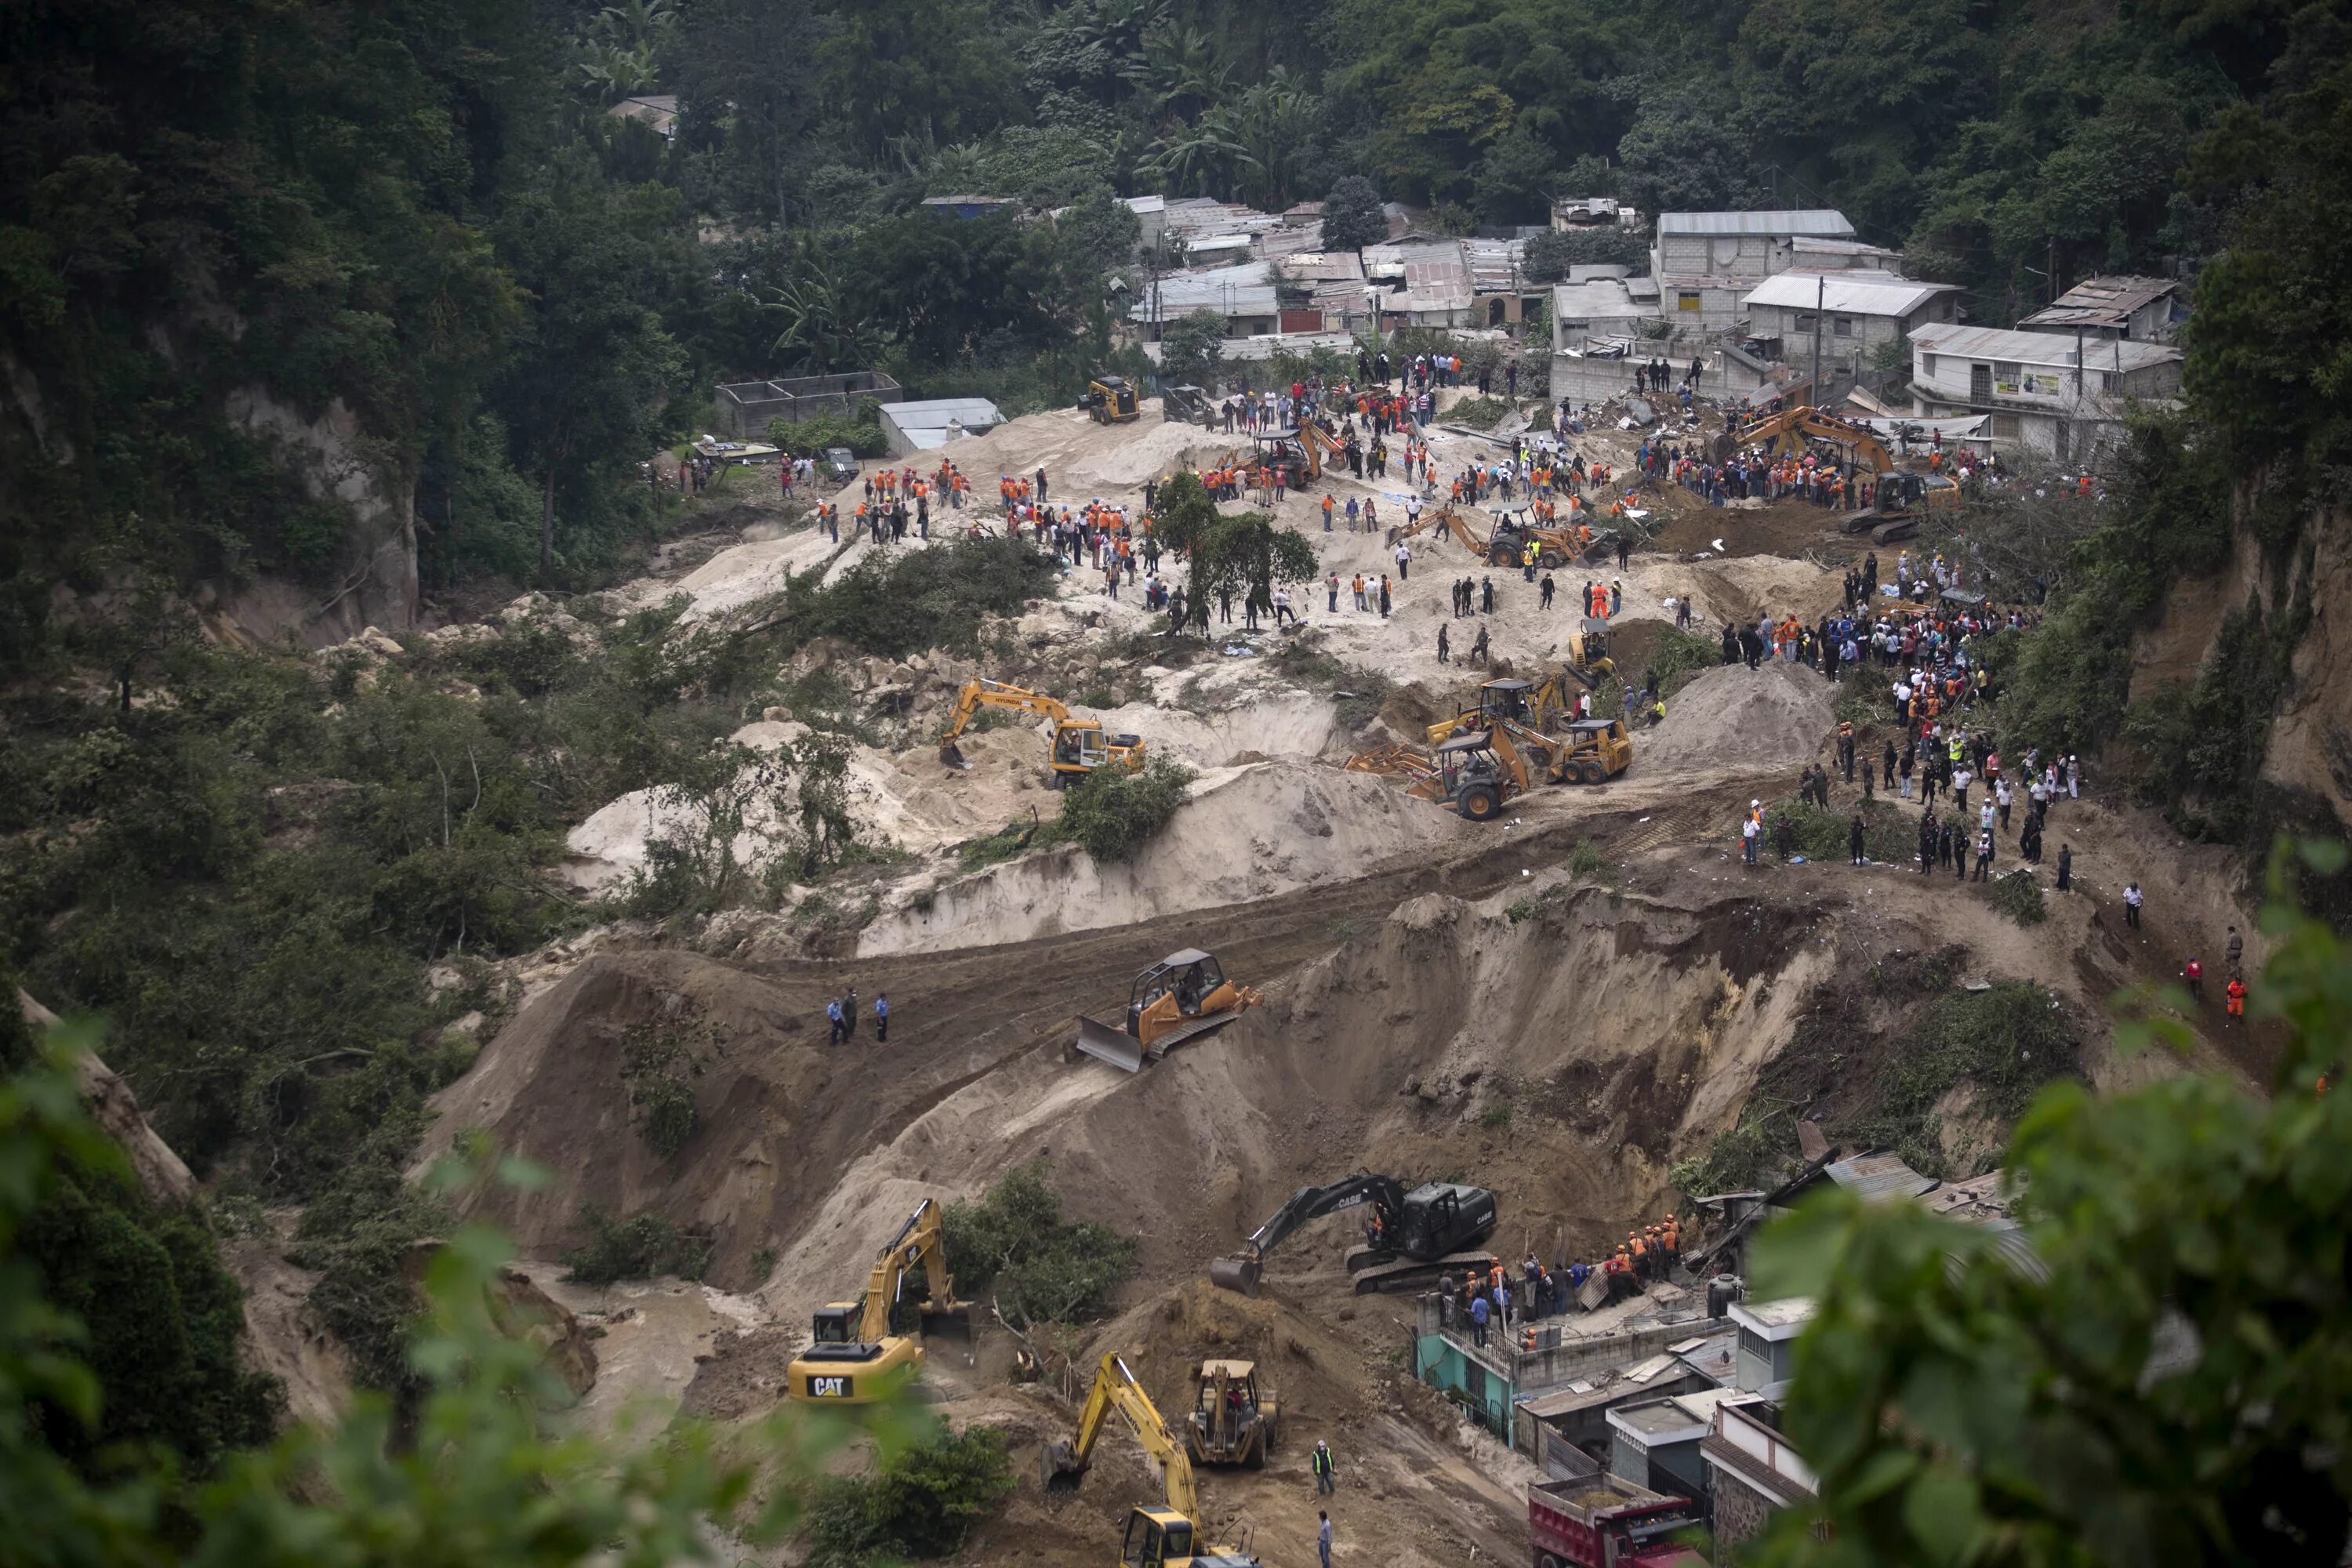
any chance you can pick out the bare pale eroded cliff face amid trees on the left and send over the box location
[205,386,416,647]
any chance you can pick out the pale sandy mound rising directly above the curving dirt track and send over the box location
[858,761,1482,956]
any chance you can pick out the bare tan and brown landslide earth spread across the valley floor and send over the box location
[362,405,2258,1563]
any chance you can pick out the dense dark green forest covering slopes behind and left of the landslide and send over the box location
[0,0,2352,1462]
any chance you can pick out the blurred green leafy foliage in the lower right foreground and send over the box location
[1748,844,2352,1568]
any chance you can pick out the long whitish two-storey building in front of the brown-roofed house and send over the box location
[1910,325,2180,468]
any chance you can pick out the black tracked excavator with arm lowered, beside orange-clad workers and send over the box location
[1209,1171,1496,1295]
